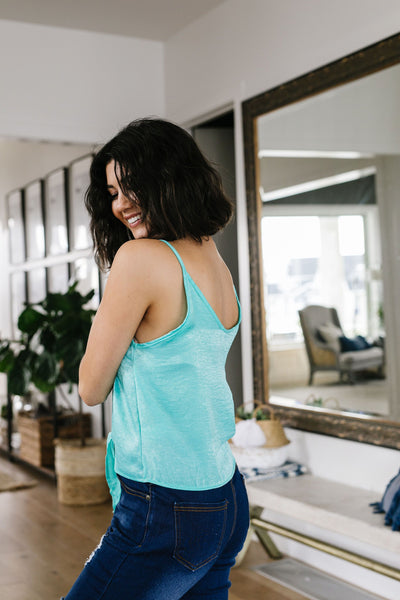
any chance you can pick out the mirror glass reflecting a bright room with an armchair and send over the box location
[257,59,400,418]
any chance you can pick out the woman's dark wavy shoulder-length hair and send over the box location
[85,118,233,268]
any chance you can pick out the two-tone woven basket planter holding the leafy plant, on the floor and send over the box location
[54,438,110,506]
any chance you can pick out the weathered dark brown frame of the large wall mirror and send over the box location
[242,34,400,449]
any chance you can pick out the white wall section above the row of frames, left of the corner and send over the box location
[0,21,164,142]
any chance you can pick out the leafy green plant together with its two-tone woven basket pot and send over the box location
[0,282,108,504]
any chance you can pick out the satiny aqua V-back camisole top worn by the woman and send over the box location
[106,240,241,506]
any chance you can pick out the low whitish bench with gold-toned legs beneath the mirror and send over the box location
[238,474,400,581]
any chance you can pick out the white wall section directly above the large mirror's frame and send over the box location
[165,0,400,121]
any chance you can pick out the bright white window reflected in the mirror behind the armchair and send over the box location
[262,209,381,347]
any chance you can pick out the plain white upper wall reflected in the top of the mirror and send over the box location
[257,65,400,155]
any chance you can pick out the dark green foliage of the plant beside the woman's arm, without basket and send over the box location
[0,282,95,446]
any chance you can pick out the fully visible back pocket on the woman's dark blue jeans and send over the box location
[173,500,228,571]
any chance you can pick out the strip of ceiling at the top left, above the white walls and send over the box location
[0,0,224,42]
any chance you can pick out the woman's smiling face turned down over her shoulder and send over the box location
[106,160,148,239]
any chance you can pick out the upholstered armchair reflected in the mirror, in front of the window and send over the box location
[299,305,385,385]
